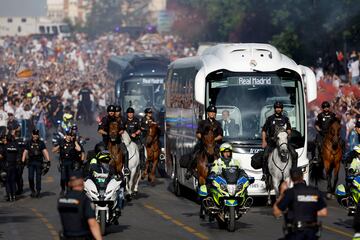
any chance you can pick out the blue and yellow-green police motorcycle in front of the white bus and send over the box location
[199,166,255,232]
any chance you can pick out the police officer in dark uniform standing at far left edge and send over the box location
[1,134,20,202]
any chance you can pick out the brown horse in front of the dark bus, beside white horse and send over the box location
[141,123,160,183]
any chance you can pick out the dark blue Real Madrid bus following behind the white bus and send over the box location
[107,53,170,163]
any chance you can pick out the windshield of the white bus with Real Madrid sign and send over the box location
[206,70,305,142]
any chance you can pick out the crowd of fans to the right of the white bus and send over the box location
[308,51,360,154]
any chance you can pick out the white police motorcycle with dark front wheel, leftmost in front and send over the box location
[84,154,124,235]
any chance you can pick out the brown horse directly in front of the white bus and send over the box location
[195,128,219,186]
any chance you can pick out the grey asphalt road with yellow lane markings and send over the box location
[0,124,353,240]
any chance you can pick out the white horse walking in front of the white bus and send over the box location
[267,128,292,204]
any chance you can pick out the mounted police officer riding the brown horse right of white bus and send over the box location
[313,101,336,163]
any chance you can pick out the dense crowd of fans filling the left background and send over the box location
[0,33,196,140]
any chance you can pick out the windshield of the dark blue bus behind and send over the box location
[123,77,164,113]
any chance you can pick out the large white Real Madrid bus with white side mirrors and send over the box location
[165,43,316,196]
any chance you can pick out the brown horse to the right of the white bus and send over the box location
[321,119,342,198]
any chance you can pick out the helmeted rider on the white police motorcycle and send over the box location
[88,142,124,217]
